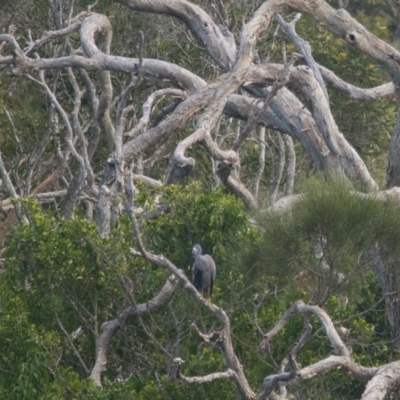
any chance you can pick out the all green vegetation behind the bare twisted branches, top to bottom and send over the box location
[0,0,400,400]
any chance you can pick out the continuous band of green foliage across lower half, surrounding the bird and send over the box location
[0,180,400,400]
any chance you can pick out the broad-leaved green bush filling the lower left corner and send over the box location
[0,202,144,399]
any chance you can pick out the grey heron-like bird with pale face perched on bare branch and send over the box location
[192,244,217,297]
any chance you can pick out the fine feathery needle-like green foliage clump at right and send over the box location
[252,179,400,302]
